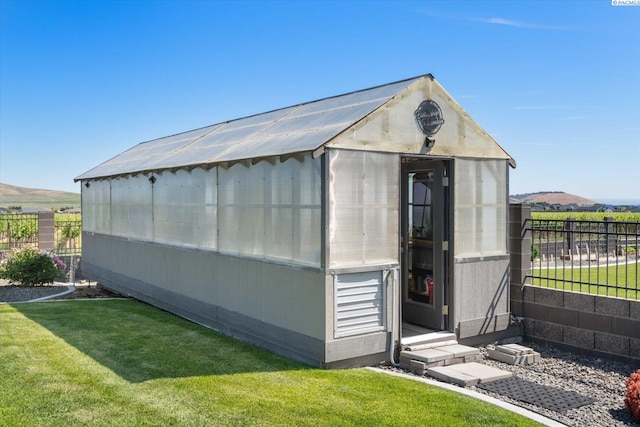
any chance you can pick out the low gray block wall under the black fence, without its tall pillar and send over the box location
[521,286,640,363]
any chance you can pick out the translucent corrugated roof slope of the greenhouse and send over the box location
[76,75,429,181]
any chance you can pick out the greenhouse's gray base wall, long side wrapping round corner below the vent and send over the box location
[81,233,391,368]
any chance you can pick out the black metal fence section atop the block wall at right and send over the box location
[527,218,640,300]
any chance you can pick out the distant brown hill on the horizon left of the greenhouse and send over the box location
[0,183,80,209]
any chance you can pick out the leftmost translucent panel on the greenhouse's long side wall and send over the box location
[81,181,111,234]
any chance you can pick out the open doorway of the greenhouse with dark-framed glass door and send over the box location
[401,157,450,335]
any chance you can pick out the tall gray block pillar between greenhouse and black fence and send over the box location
[509,204,532,316]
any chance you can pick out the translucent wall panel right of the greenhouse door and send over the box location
[455,159,508,257]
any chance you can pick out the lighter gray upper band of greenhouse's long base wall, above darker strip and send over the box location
[82,233,326,340]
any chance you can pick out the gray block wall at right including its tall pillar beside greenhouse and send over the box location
[509,204,640,364]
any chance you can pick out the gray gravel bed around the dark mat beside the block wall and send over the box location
[390,342,640,427]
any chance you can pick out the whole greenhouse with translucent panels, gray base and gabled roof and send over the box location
[76,74,515,367]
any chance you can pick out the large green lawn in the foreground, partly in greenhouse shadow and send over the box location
[0,300,537,427]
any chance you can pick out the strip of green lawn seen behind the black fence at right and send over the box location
[531,263,640,299]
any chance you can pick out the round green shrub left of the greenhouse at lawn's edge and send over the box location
[0,246,67,286]
